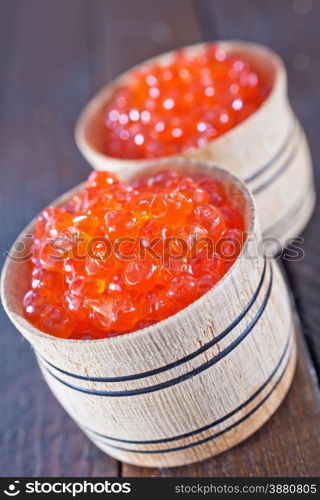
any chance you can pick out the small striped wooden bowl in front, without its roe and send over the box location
[1,160,296,467]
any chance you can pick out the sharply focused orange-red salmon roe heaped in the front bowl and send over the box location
[23,171,245,339]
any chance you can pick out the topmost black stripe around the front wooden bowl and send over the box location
[37,258,267,382]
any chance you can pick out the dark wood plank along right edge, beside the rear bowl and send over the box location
[202,0,320,372]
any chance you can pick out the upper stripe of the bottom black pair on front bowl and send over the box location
[82,323,293,449]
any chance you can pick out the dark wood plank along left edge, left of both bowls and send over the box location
[0,0,118,477]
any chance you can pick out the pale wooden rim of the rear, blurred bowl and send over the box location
[74,39,287,170]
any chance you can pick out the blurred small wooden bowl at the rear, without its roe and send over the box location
[75,41,315,249]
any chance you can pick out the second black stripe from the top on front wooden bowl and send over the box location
[39,266,273,397]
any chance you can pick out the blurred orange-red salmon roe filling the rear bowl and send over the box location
[101,44,269,159]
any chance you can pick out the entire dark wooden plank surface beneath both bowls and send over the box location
[0,0,320,476]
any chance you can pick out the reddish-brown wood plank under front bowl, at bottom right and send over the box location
[123,324,320,477]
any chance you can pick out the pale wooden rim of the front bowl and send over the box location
[0,158,260,345]
